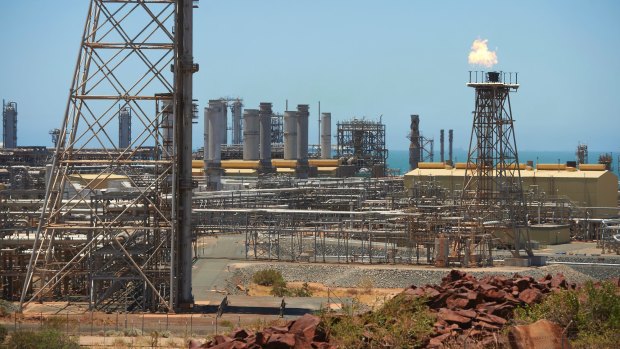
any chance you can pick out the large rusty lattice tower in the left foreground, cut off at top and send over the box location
[20,0,197,311]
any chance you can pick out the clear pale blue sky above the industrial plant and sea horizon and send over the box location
[0,0,620,152]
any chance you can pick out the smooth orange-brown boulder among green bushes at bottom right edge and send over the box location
[508,320,570,349]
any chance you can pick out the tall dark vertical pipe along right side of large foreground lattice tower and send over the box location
[171,0,198,308]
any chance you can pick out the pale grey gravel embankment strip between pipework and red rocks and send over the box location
[224,263,620,291]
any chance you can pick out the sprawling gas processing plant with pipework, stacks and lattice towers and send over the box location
[0,0,620,348]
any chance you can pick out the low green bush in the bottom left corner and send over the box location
[7,329,80,349]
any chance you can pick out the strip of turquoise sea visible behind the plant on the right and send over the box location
[388,149,620,177]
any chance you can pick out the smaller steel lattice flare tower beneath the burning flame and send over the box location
[462,72,530,253]
